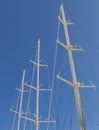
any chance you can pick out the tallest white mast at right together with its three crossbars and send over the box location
[57,4,95,130]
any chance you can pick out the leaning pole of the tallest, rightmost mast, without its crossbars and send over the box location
[60,4,85,130]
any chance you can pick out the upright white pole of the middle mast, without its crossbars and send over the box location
[36,39,40,130]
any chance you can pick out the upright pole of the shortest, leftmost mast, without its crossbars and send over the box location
[17,70,25,130]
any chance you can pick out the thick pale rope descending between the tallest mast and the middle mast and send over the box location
[47,10,60,130]
